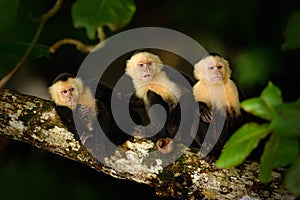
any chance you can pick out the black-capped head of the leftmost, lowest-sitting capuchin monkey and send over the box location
[49,73,83,110]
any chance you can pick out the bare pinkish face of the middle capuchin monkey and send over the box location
[135,60,156,82]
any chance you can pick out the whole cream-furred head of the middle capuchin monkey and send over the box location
[125,52,163,82]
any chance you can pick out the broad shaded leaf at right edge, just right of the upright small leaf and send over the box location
[270,99,300,138]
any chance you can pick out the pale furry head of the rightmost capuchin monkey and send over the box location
[194,54,231,83]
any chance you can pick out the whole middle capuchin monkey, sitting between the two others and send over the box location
[125,51,194,153]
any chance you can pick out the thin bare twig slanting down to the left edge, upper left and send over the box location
[0,0,63,89]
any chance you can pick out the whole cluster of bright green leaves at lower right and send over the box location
[217,82,300,194]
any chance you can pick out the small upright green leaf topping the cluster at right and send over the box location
[260,82,283,107]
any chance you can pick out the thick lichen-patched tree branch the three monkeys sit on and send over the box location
[0,90,295,199]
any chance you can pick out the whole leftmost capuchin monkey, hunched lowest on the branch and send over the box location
[49,73,111,158]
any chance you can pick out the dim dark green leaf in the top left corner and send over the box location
[0,0,20,33]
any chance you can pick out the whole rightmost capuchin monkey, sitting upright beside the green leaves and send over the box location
[193,53,241,159]
